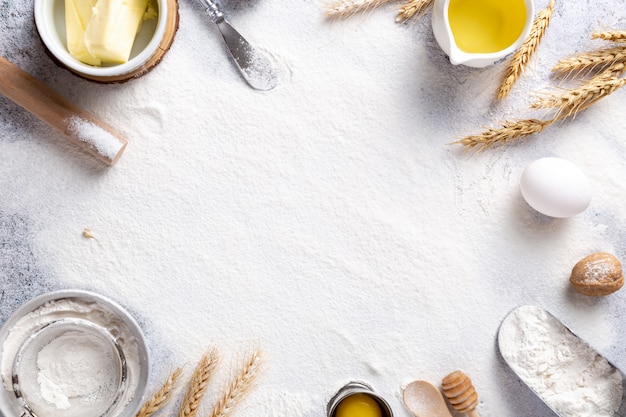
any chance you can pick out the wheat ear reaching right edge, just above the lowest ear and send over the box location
[531,63,626,118]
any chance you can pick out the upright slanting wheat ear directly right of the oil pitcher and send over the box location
[496,0,555,100]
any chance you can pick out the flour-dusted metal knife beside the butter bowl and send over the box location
[198,0,278,91]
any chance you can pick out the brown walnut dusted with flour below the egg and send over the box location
[569,252,624,297]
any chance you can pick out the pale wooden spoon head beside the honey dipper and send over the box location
[402,381,452,417]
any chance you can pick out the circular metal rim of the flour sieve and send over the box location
[11,318,128,417]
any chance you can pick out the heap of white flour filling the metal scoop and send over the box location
[499,306,624,417]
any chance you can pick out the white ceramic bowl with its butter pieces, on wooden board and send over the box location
[34,0,168,82]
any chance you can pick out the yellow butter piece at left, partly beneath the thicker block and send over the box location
[65,0,100,65]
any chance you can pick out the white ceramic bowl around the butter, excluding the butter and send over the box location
[35,0,168,79]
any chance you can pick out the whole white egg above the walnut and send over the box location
[520,157,591,218]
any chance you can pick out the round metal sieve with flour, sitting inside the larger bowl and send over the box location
[12,318,128,417]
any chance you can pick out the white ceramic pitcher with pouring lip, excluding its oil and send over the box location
[432,0,535,68]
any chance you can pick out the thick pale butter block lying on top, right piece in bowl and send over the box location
[83,0,149,64]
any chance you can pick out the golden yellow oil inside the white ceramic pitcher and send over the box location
[448,0,526,53]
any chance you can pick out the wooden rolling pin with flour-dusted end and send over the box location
[0,57,127,165]
